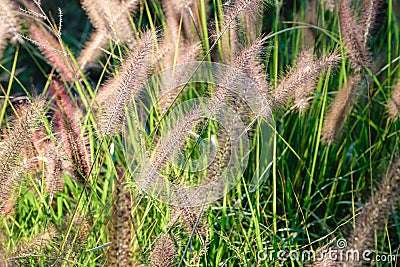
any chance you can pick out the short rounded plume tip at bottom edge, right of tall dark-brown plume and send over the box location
[150,234,178,267]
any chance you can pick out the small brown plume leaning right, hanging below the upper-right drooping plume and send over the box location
[322,75,361,145]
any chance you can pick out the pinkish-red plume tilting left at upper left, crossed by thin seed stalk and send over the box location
[28,23,79,82]
